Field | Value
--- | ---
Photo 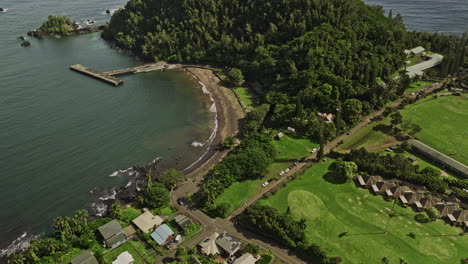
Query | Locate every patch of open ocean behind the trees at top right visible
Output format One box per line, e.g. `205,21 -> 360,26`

364,0 -> 468,35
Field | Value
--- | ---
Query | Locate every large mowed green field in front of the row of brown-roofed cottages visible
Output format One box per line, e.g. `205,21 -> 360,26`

259,161 -> 468,264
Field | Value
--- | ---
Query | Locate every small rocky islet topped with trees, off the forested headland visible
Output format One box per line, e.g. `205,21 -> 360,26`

28,15 -> 104,38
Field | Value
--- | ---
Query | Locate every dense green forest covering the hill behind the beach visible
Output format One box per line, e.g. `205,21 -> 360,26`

103,0 -> 407,134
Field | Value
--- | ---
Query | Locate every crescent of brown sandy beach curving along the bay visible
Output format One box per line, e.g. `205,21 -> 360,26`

181,67 -> 245,178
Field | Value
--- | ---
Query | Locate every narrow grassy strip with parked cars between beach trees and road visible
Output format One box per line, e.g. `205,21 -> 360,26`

215,135 -> 318,214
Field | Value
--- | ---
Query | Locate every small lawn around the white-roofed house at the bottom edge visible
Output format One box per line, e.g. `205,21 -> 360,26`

104,241 -> 156,264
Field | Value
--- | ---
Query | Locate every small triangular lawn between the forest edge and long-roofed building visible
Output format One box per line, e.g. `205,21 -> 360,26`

338,122 -> 391,150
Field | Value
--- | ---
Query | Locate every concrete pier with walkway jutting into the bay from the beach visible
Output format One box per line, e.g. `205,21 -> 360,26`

70,61 -> 182,86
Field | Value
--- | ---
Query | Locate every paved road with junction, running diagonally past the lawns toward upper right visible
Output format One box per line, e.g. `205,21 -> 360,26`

160,77 -> 450,264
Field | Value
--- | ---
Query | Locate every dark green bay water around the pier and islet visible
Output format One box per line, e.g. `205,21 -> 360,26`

0,0 -> 213,254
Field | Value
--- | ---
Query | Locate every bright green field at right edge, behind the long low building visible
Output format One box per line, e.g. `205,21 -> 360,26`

401,96 -> 468,165
